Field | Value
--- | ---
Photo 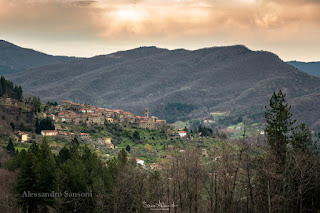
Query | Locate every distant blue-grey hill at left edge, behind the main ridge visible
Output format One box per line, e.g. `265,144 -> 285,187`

0,40 -> 77,75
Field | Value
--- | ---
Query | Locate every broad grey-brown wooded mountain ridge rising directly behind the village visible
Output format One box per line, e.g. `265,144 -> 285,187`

8,45 -> 320,130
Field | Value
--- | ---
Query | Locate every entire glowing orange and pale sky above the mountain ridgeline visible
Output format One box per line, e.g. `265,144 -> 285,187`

0,0 -> 320,61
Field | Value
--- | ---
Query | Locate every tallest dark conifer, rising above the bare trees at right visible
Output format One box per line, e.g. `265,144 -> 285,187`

265,90 -> 295,161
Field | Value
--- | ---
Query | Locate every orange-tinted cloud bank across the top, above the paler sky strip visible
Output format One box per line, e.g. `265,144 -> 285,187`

0,0 -> 320,38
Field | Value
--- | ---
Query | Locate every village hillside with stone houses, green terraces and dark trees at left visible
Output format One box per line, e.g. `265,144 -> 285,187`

0,75 -> 195,168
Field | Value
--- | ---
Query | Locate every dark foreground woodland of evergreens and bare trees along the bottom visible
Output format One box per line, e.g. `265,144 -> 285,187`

0,91 -> 320,213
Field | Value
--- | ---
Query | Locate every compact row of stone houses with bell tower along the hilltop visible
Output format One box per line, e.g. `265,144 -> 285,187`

53,100 -> 166,129
